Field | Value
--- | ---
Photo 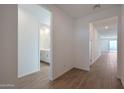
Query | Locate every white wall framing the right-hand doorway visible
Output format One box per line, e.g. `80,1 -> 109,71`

75,6 -> 121,70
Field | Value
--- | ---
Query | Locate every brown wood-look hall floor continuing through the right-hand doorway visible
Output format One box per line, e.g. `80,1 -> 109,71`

49,53 -> 122,89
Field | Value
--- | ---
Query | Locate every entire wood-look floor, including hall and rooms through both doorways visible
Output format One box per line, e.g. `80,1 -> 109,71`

18,53 -> 123,89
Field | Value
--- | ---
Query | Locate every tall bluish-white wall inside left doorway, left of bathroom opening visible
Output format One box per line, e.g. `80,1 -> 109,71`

18,5 -> 39,77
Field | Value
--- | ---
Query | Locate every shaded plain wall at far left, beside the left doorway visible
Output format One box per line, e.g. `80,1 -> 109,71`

0,5 -> 18,88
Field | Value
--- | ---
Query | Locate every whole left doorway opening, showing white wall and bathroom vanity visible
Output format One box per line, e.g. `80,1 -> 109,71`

18,4 -> 53,81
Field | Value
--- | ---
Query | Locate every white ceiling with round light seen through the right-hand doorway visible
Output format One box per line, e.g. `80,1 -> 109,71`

93,17 -> 118,37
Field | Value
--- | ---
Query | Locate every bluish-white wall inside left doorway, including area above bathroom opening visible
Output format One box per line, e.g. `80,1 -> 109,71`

18,5 -> 50,77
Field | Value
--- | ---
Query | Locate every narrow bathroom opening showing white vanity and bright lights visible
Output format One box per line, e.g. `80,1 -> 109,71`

39,20 -> 52,80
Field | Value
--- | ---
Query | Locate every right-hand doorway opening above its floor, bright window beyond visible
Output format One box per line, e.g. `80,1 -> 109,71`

89,16 -> 118,69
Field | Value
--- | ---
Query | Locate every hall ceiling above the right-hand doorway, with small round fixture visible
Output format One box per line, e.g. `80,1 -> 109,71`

56,4 -> 119,18
